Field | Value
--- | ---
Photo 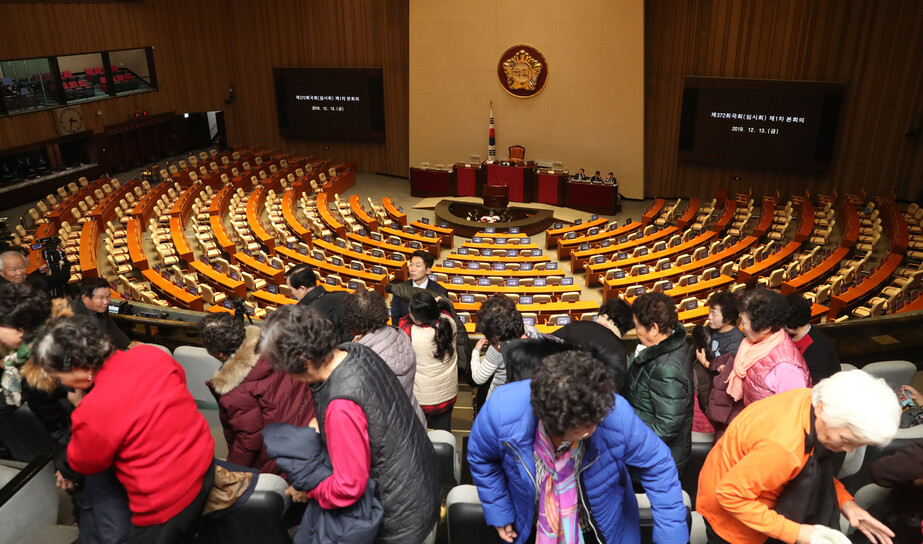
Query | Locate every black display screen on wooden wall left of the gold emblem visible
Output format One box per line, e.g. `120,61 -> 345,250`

273,67 -> 385,141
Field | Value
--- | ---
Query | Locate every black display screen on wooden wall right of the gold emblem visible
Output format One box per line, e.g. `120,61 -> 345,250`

678,77 -> 844,172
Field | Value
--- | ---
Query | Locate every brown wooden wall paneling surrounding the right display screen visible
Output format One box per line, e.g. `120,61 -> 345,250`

645,0 -> 923,200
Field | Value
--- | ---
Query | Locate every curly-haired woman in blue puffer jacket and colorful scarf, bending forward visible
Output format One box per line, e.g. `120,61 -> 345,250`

468,351 -> 689,543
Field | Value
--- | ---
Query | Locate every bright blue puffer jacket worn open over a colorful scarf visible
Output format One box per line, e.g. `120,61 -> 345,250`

468,381 -> 689,544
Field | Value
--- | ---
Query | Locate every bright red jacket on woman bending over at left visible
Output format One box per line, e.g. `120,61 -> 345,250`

67,346 -> 215,526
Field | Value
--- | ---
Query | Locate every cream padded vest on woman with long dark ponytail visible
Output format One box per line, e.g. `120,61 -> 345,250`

410,316 -> 458,406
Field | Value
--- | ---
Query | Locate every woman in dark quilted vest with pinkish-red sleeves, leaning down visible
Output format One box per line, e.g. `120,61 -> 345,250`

259,305 -> 440,544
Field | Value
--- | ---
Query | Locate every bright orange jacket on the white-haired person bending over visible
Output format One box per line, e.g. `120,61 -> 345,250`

696,389 -> 853,544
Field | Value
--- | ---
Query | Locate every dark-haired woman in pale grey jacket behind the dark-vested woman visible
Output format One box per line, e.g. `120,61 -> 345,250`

342,289 -> 426,425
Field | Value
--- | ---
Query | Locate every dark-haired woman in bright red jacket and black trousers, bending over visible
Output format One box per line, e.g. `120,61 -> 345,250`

34,316 -> 215,542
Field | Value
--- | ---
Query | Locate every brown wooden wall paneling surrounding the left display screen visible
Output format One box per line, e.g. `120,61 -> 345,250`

225,0 -> 409,176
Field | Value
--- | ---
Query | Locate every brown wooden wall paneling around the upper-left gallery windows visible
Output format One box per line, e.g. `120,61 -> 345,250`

0,0 -> 232,154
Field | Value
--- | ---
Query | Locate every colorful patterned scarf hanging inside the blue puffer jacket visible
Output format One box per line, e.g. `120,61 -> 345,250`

535,421 -> 583,544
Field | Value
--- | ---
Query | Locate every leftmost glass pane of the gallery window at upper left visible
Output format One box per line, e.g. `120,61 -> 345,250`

0,58 -> 60,113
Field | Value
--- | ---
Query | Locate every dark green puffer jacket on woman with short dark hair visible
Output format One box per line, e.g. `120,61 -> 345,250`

625,324 -> 694,476
